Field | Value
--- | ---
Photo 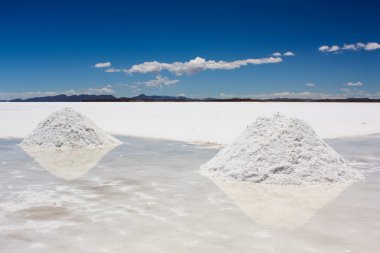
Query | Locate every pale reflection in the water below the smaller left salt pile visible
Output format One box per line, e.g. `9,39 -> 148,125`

23,146 -> 116,181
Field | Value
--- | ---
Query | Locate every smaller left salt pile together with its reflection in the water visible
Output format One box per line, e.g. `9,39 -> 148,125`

21,108 -> 121,180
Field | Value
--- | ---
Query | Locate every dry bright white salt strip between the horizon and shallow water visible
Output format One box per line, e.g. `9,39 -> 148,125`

0,102 -> 380,144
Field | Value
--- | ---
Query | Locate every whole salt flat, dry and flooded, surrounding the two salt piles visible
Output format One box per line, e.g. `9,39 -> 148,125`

0,103 -> 380,253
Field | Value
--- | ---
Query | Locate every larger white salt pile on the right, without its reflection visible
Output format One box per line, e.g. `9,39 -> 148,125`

200,114 -> 363,185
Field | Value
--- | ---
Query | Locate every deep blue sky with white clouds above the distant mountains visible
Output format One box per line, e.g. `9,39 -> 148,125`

0,0 -> 380,99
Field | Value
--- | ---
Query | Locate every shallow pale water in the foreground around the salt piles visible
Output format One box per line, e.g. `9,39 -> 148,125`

0,135 -> 380,253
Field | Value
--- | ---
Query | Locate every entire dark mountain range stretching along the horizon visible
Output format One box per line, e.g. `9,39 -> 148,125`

0,94 -> 380,102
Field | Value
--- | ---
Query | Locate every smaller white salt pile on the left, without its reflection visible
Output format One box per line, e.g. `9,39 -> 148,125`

21,108 -> 121,149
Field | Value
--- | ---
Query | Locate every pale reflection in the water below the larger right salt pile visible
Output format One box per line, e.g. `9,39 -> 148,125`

212,178 -> 351,230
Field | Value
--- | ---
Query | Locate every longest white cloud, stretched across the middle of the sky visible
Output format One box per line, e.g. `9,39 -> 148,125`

124,57 -> 282,76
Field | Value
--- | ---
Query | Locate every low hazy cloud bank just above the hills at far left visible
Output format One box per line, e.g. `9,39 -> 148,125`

0,85 -> 115,100
